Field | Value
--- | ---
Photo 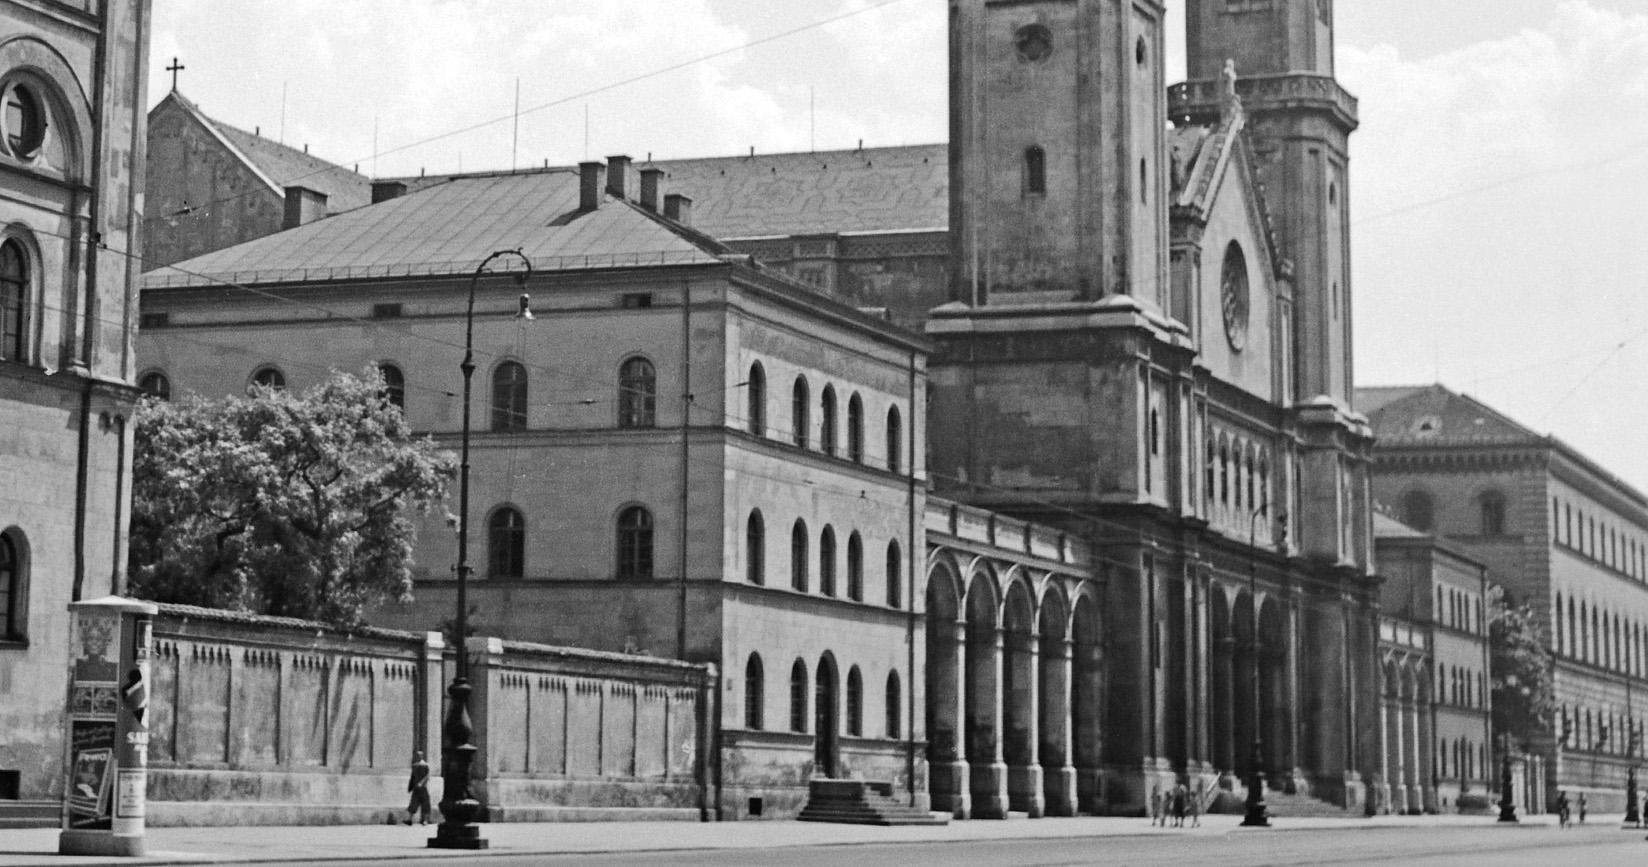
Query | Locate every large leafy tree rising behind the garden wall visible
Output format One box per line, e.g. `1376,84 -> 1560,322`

130,369 -> 455,626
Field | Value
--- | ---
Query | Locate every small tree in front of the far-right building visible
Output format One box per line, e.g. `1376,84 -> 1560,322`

1488,585 -> 1556,743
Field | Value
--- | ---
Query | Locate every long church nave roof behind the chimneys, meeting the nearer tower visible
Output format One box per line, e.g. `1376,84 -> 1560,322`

394,143 -> 949,241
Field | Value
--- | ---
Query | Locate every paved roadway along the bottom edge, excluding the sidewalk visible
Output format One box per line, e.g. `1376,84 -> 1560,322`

276,826 -> 1648,867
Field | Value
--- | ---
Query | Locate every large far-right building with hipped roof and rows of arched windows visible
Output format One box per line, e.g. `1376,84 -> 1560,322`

1360,386 -> 1648,813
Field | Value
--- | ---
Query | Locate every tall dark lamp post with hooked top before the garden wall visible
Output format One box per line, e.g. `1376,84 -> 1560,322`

428,249 -> 532,849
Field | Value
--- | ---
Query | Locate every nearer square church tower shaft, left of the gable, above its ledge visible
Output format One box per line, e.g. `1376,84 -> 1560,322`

949,0 -> 1168,308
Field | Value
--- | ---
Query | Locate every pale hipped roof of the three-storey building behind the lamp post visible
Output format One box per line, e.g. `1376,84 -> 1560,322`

143,170 -> 727,288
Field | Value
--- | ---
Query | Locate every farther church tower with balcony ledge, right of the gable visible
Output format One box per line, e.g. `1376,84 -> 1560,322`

1170,0 -> 1356,407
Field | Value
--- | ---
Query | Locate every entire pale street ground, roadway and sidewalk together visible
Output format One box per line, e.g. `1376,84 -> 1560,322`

0,816 -> 1648,867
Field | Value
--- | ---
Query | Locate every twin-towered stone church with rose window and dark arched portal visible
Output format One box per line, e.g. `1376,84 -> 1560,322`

926,0 -> 1378,809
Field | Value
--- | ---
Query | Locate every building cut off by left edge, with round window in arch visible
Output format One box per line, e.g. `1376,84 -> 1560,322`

0,0 -> 150,821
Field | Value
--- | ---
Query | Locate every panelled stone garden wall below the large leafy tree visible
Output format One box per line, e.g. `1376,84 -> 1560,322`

148,605 -> 715,826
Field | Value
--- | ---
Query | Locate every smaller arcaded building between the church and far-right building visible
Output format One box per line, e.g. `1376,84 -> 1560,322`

1373,514 -> 1500,813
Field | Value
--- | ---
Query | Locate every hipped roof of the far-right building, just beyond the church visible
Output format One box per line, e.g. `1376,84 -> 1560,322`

1356,384 -> 1546,445
